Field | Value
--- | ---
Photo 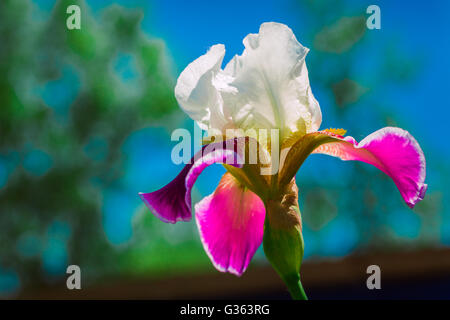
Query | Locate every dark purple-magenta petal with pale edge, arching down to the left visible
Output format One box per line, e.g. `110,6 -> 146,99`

139,138 -> 243,223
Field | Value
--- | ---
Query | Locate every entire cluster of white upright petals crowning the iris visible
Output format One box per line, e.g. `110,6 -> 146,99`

175,22 -> 322,138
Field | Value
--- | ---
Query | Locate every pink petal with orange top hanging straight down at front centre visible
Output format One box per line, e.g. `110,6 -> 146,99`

195,173 -> 265,276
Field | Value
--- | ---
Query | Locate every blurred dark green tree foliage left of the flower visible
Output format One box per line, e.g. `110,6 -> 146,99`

0,0 -> 177,287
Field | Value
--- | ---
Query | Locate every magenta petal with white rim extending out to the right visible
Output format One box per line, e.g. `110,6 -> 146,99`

314,127 -> 427,208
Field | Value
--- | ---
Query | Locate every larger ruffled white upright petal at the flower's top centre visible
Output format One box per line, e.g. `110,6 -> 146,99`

219,22 -> 322,137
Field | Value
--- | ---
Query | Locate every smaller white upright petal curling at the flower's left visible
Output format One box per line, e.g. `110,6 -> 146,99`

175,44 -> 225,130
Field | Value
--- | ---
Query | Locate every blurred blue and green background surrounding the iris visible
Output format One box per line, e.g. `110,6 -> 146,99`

0,0 -> 450,299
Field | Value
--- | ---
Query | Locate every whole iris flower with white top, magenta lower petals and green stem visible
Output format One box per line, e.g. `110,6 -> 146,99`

140,22 -> 427,299
